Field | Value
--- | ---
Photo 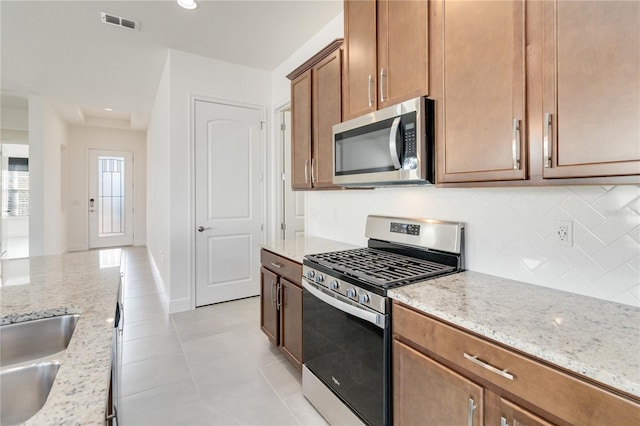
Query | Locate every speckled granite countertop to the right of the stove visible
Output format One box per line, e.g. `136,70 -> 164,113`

389,271 -> 640,397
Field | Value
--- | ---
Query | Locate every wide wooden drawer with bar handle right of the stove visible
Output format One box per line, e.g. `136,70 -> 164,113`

393,302 -> 640,425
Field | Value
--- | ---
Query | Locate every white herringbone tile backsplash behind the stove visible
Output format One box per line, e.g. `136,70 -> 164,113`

307,185 -> 640,306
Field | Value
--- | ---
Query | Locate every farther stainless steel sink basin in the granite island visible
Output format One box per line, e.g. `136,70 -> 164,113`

0,315 -> 80,366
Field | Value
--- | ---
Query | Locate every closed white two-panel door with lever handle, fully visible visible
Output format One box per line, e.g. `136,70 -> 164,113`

194,100 -> 262,306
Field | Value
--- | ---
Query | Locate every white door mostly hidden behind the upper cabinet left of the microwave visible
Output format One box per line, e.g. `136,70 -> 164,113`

280,109 -> 306,238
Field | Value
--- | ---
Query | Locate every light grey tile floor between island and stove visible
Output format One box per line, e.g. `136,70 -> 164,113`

119,247 -> 326,426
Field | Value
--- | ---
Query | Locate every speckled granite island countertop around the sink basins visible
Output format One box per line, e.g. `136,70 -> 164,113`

0,250 -> 120,425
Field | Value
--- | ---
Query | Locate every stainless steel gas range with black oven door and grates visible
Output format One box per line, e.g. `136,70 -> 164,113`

302,216 -> 464,425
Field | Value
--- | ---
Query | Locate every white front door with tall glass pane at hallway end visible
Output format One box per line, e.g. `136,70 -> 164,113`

88,149 -> 133,248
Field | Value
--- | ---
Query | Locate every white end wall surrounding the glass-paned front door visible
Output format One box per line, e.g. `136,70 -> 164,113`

63,126 -> 147,251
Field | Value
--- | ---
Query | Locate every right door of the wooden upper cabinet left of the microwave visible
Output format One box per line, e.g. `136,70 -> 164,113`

311,49 -> 342,188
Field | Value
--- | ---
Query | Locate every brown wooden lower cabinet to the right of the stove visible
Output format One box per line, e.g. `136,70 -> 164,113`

393,302 -> 640,426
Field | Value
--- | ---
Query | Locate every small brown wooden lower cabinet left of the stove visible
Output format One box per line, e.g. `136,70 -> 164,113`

260,249 -> 302,371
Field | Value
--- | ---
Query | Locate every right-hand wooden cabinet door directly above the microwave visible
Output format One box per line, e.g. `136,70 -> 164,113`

377,0 -> 429,109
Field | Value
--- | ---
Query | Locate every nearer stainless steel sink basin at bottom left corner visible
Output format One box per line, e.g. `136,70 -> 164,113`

0,361 -> 60,425
